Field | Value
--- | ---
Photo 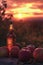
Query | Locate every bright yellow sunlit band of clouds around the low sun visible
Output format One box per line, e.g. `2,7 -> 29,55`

6,3 -> 43,19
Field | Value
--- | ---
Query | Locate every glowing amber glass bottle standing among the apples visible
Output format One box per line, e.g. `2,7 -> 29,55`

7,22 -> 16,52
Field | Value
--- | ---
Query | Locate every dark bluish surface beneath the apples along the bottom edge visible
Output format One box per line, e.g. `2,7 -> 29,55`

0,58 -> 43,65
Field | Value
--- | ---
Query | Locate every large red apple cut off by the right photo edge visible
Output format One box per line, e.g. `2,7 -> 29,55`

33,48 -> 43,62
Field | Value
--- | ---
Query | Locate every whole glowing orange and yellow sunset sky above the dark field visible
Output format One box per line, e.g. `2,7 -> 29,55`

0,0 -> 43,19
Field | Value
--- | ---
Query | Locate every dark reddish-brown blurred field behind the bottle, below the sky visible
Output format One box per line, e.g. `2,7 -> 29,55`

0,19 -> 43,46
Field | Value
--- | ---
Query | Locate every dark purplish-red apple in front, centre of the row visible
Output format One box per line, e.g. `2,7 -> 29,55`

19,48 -> 31,62
